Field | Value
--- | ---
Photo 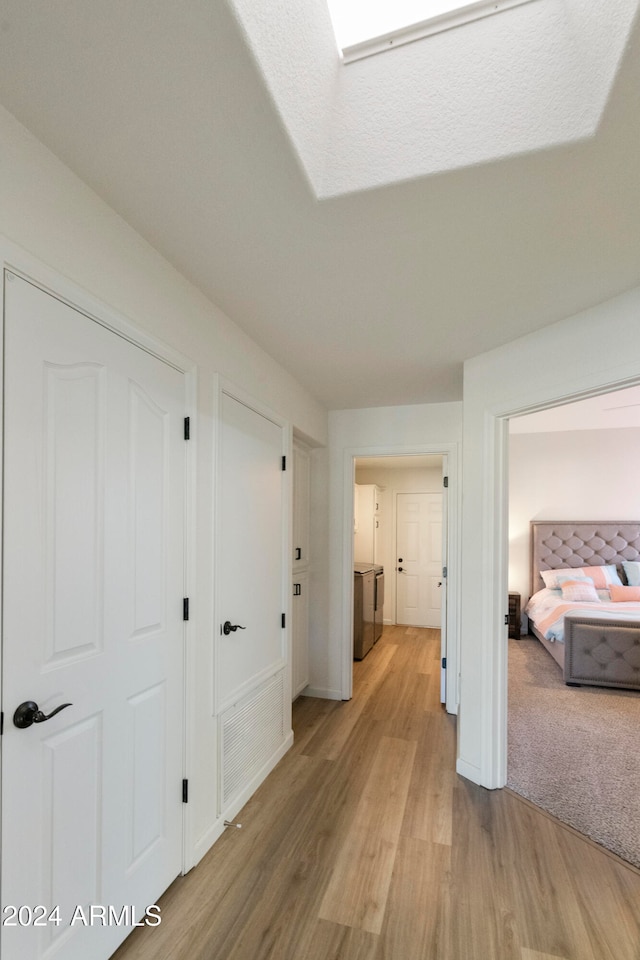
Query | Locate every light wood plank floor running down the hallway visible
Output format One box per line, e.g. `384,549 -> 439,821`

115,627 -> 640,960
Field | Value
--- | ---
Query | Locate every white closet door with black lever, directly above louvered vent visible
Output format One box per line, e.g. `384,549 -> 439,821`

217,392 -> 287,710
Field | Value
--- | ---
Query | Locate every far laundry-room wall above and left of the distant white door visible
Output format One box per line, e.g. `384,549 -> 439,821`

356,461 -> 442,624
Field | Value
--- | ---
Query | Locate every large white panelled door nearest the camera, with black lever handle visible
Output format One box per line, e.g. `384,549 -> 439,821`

1,275 -> 185,960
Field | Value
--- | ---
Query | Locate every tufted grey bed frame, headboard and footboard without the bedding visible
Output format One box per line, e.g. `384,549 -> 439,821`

530,520 -> 640,690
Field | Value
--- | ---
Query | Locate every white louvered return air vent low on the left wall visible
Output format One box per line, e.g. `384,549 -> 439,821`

222,672 -> 284,809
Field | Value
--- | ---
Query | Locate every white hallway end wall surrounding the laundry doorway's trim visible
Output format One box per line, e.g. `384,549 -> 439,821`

318,403 -> 462,699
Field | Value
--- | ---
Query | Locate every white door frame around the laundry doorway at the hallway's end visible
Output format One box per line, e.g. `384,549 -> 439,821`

341,443 -> 461,713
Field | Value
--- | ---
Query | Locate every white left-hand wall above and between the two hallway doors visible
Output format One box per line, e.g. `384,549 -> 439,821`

0,108 -> 327,868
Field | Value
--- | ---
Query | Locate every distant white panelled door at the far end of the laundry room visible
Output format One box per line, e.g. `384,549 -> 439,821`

396,493 -> 442,627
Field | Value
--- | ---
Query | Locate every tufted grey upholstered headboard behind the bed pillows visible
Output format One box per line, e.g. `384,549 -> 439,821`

531,520 -> 640,593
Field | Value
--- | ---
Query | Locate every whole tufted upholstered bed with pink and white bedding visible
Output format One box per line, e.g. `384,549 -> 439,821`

525,520 -> 640,690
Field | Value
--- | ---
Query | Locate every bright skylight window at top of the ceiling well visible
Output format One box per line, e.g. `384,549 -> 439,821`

327,0 -> 532,63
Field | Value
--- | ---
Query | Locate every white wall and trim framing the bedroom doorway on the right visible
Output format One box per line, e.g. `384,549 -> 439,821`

458,288 -> 640,787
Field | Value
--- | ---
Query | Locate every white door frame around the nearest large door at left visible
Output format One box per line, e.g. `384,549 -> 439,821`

0,236 -> 197,873
